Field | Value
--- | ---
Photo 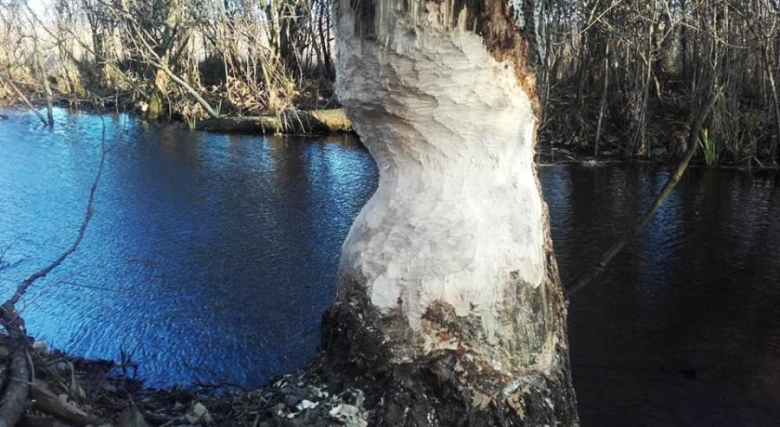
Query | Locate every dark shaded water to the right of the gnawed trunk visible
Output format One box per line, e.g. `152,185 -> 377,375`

542,166 -> 780,426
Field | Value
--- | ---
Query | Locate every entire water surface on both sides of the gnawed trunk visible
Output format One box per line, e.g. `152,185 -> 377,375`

0,112 -> 780,426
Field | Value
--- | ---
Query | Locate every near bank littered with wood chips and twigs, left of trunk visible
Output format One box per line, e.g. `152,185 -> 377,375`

0,336 -> 368,427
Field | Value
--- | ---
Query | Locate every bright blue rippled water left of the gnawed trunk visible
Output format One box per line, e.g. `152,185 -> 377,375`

0,111 -> 376,386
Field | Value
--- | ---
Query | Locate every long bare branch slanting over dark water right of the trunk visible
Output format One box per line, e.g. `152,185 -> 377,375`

566,89 -> 721,298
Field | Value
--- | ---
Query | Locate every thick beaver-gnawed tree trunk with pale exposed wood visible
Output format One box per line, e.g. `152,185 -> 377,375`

323,0 -> 577,426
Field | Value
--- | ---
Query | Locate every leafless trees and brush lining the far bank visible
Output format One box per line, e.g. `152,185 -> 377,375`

0,0 -> 780,165
